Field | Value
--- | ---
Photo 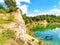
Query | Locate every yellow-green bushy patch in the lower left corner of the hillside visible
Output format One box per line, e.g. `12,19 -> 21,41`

0,29 -> 15,45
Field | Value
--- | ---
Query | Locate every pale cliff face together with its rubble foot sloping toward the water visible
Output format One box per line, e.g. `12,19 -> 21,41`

10,9 -> 38,45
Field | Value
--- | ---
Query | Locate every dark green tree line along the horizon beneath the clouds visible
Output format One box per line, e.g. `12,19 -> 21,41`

23,14 -> 60,24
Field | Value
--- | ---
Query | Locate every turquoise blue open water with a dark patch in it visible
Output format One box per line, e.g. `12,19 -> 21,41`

34,28 -> 60,45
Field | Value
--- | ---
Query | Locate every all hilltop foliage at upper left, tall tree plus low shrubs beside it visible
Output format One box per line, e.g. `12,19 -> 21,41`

0,0 -> 17,13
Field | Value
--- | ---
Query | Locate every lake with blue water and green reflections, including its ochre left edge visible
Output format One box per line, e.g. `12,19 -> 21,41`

27,23 -> 60,45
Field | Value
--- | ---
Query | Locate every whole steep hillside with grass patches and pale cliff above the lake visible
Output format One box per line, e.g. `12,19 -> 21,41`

0,8 -> 42,45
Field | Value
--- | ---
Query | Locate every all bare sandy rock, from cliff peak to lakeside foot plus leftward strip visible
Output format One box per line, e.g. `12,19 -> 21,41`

0,8 -> 39,45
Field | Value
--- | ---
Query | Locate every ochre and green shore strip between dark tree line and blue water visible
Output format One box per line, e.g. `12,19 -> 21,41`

26,22 -> 60,35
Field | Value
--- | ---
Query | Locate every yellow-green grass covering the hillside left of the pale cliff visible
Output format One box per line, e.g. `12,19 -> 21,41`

0,9 -> 24,45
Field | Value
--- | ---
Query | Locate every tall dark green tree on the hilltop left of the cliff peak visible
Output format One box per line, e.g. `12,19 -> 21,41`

4,0 -> 17,12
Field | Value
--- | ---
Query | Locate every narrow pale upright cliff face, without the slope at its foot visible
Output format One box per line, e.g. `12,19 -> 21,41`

12,9 -> 26,40
